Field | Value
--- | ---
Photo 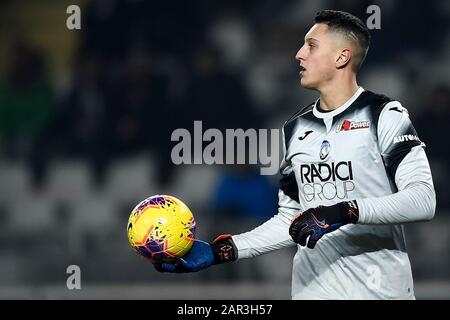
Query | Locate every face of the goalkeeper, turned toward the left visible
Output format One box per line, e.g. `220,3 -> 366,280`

295,23 -> 339,89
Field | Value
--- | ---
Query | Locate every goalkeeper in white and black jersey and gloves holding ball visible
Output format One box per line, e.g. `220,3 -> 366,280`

156,10 -> 436,299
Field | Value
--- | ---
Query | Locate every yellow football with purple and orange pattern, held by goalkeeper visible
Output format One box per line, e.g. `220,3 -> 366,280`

127,195 -> 195,263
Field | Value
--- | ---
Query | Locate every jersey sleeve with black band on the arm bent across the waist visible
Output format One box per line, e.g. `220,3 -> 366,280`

357,101 -> 436,224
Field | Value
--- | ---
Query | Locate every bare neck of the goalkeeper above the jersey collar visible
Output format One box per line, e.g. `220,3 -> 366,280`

319,79 -> 358,111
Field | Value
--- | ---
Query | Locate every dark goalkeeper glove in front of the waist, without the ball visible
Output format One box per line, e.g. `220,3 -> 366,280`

289,201 -> 359,249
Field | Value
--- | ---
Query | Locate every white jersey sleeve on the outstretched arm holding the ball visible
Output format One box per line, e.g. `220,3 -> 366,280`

233,126 -> 300,259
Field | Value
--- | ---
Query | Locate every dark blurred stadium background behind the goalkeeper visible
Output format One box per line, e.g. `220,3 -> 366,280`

0,0 -> 450,299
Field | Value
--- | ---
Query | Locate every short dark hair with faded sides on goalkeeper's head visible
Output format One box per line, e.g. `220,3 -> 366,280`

314,10 -> 370,71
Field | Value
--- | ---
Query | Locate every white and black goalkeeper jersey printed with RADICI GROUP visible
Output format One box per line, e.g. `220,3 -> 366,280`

233,88 -> 436,299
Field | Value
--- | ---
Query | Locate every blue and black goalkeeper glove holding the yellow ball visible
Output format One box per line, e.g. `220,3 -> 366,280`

155,234 -> 237,273
